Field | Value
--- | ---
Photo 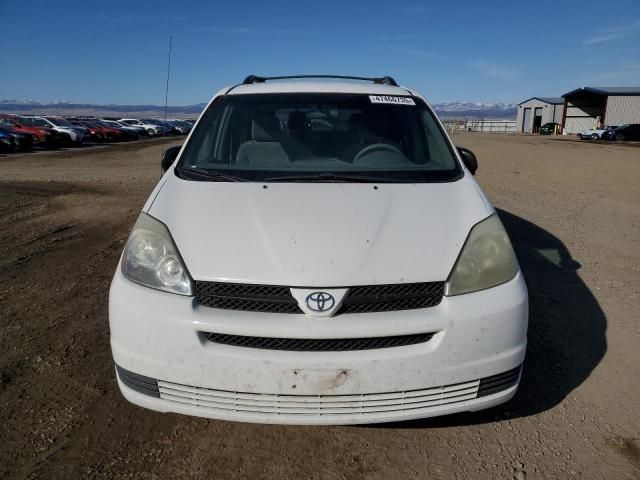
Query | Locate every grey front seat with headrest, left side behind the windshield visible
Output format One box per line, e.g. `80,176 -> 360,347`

236,115 -> 289,168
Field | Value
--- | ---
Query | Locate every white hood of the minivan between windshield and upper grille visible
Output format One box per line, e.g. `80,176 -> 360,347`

148,177 -> 492,287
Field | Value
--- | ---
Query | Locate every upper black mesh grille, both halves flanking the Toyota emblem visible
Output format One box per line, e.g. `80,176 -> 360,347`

196,281 -> 444,315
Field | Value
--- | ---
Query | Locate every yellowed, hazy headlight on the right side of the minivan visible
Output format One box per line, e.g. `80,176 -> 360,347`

445,214 -> 518,296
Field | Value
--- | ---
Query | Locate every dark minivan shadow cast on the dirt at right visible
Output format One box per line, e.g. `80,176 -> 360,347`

379,209 -> 607,428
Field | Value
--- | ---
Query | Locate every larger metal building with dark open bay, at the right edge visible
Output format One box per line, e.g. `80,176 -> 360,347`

560,87 -> 640,133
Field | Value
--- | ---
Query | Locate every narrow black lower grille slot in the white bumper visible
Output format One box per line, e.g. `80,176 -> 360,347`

206,333 -> 433,352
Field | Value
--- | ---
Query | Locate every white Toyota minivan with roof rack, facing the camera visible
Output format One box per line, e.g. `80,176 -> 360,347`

109,75 -> 528,424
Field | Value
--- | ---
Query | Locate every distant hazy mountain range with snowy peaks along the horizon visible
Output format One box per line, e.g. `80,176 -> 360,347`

0,100 -> 518,120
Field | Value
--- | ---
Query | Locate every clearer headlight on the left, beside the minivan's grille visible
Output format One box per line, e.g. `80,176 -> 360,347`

122,213 -> 193,295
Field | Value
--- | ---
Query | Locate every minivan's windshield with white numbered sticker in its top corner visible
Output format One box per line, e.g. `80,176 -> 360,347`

177,93 -> 462,182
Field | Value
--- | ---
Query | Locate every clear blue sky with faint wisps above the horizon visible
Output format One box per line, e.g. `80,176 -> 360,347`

0,0 -> 640,105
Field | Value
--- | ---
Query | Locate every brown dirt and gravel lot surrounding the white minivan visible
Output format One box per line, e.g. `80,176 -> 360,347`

0,134 -> 640,479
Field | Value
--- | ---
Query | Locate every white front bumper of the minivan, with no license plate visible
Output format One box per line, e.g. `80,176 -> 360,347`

109,270 -> 528,424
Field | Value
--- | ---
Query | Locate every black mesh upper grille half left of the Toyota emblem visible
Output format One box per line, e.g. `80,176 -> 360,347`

196,282 -> 302,313
